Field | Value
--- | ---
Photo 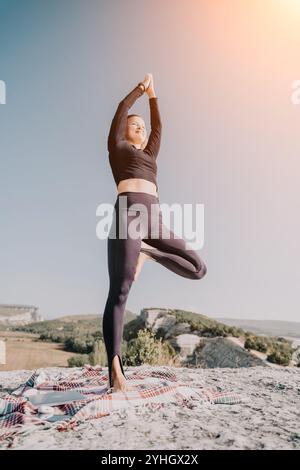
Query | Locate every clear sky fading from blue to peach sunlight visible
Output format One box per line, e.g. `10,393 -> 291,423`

0,0 -> 300,320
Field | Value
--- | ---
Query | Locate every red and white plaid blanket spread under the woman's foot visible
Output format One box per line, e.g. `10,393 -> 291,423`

0,365 -> 243,440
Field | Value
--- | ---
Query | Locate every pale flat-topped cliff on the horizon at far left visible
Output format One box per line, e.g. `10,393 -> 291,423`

0,304 -> 43,326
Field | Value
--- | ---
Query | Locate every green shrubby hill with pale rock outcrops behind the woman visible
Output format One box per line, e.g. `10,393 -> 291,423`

2,308 -> 300,368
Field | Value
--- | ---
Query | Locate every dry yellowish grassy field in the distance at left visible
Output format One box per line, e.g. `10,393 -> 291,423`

0,331 -> 81,371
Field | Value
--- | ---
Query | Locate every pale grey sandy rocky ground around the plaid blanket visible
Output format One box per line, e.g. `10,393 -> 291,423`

0,367 -> 300,450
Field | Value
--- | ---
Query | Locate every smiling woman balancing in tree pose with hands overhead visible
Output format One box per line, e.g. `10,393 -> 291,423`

103,73 -> 207,392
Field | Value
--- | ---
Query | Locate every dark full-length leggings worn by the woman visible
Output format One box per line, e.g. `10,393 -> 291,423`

103,191 -> 207,387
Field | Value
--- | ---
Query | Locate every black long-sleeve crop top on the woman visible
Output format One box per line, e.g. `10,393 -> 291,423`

107,85 -> 162,188
